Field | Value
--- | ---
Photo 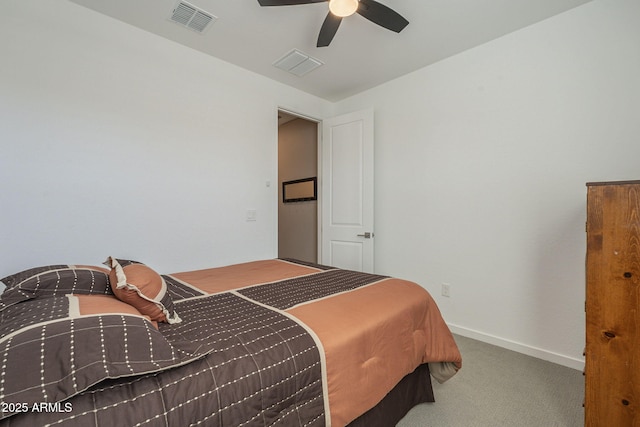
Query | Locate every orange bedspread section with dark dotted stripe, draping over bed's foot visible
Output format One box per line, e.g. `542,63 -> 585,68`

173,260 -> 462,426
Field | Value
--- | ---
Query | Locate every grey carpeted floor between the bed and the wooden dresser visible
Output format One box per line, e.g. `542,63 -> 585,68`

397,335 -> 584,427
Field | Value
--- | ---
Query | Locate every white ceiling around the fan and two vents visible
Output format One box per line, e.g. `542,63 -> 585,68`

71,0 -> 591,101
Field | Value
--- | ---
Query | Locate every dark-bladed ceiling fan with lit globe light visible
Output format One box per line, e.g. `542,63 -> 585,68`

258,0 -> 409,47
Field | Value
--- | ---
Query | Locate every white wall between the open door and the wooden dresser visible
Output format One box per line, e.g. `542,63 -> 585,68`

337,0 -> 640,368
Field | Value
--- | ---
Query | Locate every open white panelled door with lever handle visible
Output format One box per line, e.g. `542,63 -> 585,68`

320,109 -> 374,273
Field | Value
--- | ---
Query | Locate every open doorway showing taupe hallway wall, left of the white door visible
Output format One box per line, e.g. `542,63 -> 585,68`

278,110 -> 318,262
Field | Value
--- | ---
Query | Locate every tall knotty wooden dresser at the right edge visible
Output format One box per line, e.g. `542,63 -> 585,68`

585,181 -> 640,427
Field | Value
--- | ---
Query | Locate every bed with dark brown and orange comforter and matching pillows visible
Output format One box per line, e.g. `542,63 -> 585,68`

0,257 -> 462,427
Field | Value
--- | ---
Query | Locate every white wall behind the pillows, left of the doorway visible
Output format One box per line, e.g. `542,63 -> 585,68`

0,0 -> 331,277
